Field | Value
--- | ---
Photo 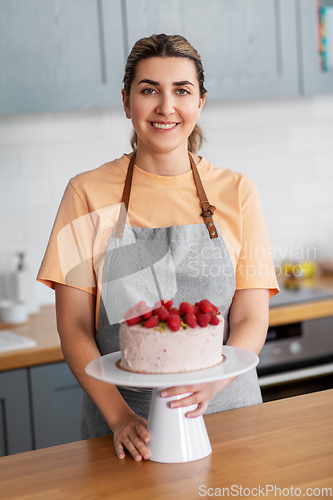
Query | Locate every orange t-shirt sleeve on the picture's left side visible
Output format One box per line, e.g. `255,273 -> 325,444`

37,181 -> 96,295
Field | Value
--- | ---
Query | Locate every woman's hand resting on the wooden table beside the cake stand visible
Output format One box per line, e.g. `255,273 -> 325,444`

113,413 -> 150,461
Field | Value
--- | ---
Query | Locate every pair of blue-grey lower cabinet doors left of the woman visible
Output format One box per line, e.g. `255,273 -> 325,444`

0,362 -> 82,456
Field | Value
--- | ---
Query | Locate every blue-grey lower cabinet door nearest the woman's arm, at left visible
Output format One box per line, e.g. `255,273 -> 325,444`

29,362 -> 82,449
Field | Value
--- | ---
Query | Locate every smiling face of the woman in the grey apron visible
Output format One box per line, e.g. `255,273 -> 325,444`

122,57 -> 206,154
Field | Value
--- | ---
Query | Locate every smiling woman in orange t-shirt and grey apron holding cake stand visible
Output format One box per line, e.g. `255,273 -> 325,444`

38,34 -> 278,460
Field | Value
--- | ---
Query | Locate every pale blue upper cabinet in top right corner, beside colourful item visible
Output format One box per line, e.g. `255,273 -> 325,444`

297,0 -> 333,95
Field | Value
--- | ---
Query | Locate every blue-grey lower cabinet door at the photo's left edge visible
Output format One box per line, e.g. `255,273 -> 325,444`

0,368 -> 33,457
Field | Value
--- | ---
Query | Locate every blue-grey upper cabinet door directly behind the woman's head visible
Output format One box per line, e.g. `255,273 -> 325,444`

126,0 -> 298,102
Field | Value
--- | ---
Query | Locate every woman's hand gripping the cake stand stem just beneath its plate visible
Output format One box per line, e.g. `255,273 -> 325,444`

162,379 -> 234,418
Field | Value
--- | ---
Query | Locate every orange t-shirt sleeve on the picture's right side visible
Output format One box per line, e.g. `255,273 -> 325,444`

236,177 -> 279,296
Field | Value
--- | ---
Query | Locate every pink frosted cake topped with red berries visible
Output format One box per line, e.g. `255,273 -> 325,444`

119,300 -> 224,373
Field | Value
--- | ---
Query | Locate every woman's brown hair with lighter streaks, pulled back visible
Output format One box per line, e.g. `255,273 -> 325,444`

123,33 -> 207,153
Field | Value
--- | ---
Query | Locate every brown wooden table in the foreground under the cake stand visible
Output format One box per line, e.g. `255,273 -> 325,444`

0,390 -> 333,500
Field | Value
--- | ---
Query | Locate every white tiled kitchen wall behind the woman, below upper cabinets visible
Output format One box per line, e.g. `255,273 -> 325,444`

0,95 -> 333,305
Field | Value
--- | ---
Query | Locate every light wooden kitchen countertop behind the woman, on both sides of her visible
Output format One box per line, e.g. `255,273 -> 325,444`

0,275 -> 333,372
